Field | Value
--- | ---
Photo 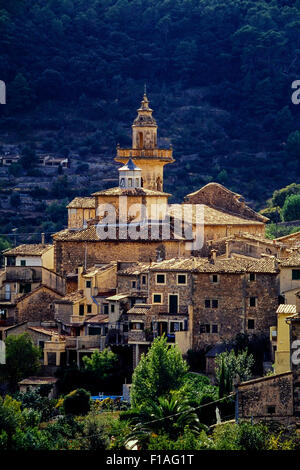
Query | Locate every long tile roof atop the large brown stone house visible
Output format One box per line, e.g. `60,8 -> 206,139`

149,257 -> 279,274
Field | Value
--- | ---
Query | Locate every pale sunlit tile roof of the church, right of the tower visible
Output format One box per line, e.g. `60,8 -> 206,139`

169,204 -> 264,225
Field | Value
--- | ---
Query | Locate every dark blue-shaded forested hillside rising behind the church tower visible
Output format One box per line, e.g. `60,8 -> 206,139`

0,0 -> 300,239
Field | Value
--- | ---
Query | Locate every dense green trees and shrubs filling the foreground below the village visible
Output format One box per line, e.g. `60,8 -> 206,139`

0,338 -> 297,451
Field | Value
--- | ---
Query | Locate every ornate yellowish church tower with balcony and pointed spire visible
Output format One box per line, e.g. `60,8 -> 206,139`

115,90 -> 174,191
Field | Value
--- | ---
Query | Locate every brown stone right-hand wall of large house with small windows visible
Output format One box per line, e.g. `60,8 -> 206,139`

192,273 -> 279,349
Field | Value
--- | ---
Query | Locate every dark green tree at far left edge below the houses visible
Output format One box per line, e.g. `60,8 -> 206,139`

4,333 -> 40,387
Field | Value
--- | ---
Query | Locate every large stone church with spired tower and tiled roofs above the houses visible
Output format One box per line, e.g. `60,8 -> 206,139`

53,94 -> 268,275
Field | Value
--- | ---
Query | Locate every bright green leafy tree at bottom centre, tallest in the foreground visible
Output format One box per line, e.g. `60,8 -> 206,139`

131,336 -> 188,406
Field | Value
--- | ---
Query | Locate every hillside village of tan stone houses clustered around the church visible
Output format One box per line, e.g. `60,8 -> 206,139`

0,93 -> 300,430
